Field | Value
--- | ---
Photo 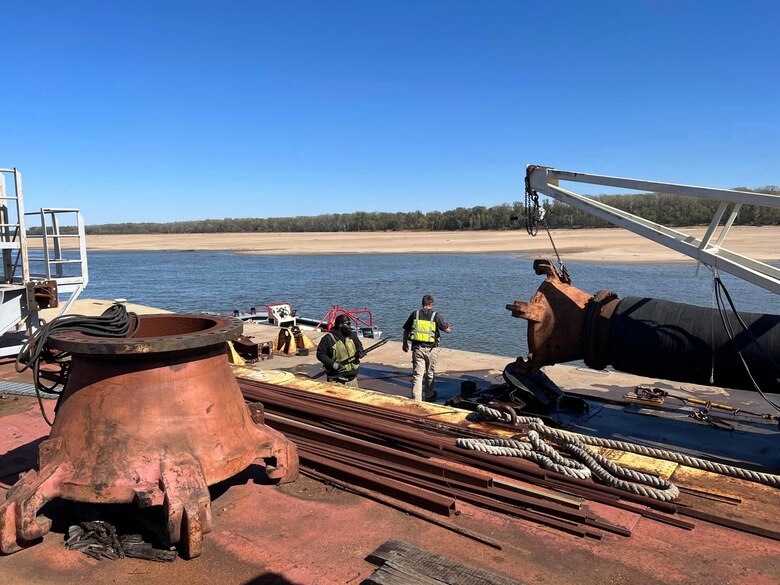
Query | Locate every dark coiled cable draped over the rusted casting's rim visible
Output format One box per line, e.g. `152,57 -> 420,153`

16,303 -> 140,426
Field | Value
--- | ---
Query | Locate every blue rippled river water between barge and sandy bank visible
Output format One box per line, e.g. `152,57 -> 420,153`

82,252 -> 780,357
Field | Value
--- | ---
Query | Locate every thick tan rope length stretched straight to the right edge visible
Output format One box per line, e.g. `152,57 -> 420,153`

464,404 -> 780,487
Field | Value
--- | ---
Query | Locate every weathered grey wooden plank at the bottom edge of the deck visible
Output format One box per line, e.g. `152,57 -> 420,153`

366,540 -> 522,585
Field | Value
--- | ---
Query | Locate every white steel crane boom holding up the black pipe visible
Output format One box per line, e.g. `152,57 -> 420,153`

526,165 -> 780,294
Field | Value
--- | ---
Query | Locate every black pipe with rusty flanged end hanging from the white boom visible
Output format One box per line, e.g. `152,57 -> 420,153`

506,260 -> 780,391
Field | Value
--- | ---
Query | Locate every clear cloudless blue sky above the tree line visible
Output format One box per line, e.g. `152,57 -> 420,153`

0,0 -> 780,223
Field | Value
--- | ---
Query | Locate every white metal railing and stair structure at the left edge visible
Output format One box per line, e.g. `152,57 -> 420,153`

0,169 -> 89,356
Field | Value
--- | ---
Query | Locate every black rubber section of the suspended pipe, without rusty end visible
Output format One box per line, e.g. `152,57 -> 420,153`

606,297 -> 780,393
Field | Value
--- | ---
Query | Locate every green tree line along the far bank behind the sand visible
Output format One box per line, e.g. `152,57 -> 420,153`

82,185 -> 780,234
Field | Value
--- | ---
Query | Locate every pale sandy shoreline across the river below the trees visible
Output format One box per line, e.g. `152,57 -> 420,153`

74,226 -> 780,263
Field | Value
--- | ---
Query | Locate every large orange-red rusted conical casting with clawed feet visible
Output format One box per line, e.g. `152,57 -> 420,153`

0,315 -> 298,558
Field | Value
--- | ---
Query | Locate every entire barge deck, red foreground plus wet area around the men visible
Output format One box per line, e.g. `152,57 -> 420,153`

0,301 -> 780,585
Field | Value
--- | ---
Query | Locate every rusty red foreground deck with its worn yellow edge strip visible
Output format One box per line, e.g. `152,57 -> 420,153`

0,346 -> 780,585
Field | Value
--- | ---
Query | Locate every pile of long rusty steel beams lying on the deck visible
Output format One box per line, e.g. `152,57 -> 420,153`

238,378 -> 780,544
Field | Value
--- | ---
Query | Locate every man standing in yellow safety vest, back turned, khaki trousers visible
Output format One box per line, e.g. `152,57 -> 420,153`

403,295 -> 452,402
